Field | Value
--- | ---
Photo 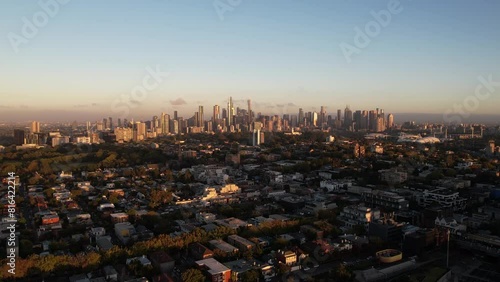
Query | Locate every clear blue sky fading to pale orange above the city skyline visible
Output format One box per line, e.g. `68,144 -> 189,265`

0,0 -> 500,121
